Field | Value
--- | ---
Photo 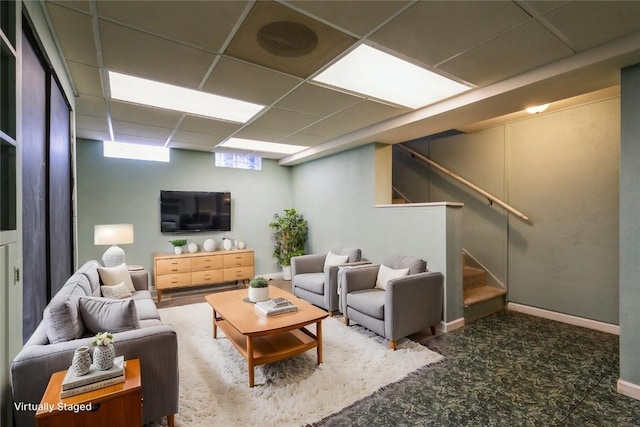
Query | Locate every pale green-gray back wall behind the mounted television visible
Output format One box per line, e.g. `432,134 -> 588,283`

77,140 -> 292,274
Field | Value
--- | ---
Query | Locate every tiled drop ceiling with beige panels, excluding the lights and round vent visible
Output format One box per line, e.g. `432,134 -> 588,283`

43,0 -> 640,165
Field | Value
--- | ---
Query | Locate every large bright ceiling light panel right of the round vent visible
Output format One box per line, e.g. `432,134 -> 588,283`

313,45 -> 470,108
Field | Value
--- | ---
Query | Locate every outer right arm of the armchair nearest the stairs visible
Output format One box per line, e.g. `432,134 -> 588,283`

384,272 -> 444,340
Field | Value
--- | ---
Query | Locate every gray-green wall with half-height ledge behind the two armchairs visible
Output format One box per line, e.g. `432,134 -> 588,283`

292,144 -> 463,322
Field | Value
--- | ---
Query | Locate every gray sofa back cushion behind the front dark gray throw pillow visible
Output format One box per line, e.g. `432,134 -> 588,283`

42,275 -> 86,343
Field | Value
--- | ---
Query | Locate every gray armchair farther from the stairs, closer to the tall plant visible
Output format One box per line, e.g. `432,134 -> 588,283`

291,248 -> 368,314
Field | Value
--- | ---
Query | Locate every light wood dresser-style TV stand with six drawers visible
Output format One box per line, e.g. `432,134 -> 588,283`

153,249 -> 255,301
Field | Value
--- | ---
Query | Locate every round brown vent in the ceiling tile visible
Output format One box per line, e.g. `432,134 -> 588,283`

258,21 -> 318,57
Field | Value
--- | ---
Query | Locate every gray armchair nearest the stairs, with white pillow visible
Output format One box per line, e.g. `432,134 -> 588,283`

339,256 -> 444,350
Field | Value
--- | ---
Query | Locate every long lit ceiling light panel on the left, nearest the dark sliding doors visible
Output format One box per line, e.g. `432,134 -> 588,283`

109,71 -> 264,123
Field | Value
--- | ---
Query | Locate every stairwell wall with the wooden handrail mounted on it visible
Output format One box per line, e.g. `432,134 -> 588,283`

394,98 -> 620,324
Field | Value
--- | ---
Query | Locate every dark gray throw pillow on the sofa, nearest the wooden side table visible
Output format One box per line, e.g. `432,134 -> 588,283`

78,297 -> 140,334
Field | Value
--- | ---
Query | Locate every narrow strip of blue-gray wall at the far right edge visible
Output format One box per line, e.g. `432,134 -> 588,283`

620,65 -> 640,388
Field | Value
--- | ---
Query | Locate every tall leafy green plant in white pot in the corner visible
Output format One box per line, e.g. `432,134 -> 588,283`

269,209 -> 309,280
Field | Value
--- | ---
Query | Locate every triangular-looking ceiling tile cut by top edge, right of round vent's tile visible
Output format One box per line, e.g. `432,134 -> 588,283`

291,0 -> 409,36
